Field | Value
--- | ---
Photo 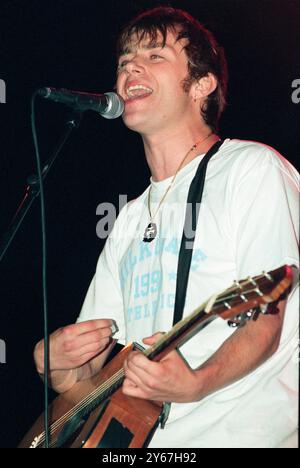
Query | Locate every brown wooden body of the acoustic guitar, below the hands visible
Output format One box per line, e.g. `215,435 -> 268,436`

19,344 -> 162,448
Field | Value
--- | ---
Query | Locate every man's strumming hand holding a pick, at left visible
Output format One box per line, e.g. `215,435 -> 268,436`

34,319 -> 114,374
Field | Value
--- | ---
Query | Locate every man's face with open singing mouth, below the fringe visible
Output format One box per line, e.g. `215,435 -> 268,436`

117,32 -> 191,135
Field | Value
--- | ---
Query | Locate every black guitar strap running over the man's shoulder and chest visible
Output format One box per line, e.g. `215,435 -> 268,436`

173,140 -> 223,325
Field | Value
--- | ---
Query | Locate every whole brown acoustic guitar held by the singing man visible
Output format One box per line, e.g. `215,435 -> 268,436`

19,265 -> 296,448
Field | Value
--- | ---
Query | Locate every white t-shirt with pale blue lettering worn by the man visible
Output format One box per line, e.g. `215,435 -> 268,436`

78,139 -> 299,448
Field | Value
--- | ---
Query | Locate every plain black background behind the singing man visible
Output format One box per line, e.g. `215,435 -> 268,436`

0,0 -> 300,447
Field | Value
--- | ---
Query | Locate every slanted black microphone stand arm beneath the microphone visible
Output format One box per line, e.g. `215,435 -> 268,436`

0,111 -> 81,261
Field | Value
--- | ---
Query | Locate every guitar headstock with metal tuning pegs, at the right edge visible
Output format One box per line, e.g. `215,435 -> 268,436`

212,265 -> 297,320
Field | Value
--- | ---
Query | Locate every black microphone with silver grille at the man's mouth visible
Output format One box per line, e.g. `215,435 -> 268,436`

38,88 -> 124,119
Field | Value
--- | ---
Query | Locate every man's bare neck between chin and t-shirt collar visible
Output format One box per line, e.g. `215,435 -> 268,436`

142,125 -> 219,182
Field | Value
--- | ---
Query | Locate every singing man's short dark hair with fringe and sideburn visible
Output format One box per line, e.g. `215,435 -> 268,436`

117,6 -> 228,131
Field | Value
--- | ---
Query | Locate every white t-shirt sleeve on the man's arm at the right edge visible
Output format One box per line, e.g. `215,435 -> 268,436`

230,145 -> 299,279
